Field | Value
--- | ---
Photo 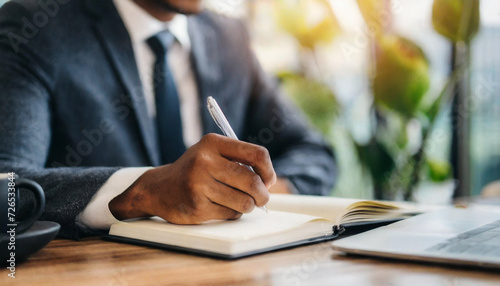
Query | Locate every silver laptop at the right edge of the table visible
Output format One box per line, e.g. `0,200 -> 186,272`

333,207 -> 500,268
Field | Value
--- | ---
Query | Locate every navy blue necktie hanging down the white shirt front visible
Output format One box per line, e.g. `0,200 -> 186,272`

147,31 -> 186,164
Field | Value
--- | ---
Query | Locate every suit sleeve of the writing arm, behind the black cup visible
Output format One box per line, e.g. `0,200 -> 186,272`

0,3 -> 118,239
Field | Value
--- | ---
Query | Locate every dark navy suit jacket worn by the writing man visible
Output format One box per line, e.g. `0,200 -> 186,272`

0,0 -> 335,238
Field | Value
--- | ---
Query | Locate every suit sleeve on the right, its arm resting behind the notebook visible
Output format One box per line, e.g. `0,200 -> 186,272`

237,24 -> 337,195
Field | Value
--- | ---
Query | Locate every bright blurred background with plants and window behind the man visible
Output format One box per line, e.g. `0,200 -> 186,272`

0,0 -> 500,203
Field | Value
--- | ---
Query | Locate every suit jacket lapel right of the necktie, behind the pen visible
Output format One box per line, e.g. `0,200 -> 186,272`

188,15 -> 224,134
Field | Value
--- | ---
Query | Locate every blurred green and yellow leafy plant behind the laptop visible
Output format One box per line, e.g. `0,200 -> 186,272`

355,0 -> 479,199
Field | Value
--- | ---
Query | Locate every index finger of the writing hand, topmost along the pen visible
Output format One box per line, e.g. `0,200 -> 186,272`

206,135 -> 276,189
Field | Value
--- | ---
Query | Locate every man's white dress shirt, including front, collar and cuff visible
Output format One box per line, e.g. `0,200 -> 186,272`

76,0 -> 202,229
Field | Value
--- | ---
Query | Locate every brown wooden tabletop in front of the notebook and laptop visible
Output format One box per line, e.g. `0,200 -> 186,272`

0,238 -> 500,286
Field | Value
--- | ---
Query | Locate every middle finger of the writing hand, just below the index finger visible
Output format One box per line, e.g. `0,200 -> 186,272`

209,157 -> 269,206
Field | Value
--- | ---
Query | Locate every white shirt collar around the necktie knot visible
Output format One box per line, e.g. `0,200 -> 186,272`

113,0 -> 191,49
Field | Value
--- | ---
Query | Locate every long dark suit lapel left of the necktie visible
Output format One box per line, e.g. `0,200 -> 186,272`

83,0 -> 160,166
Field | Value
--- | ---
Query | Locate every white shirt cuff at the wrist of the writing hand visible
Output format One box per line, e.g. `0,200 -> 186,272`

76,167 -> 152,229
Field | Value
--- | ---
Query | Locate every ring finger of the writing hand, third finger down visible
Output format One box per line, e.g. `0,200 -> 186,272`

205,182 -> 255,213
